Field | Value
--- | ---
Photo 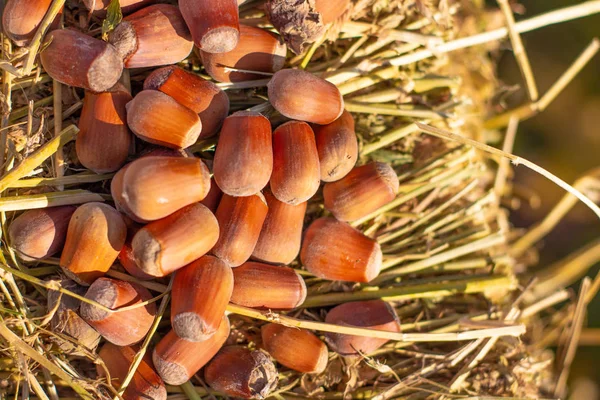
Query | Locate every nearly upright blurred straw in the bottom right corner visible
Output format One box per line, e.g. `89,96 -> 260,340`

554,277 -> 591,398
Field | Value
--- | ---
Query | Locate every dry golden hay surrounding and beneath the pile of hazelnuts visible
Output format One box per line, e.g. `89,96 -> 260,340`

0,0 -> 600,400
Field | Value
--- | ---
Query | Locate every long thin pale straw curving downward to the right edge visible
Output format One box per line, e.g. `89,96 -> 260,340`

416,122 -> 600,222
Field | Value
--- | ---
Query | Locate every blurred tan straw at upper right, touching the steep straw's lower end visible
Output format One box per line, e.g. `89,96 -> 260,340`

485,38 -> 600,129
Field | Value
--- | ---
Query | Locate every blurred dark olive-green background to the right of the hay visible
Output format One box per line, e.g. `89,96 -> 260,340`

488,0 -> 600,394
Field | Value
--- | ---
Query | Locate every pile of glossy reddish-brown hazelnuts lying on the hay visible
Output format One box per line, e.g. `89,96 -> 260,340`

3,0 -> 399,399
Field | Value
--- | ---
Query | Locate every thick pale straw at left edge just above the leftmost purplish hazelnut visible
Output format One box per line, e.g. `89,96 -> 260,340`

0,189 -> 112,212
